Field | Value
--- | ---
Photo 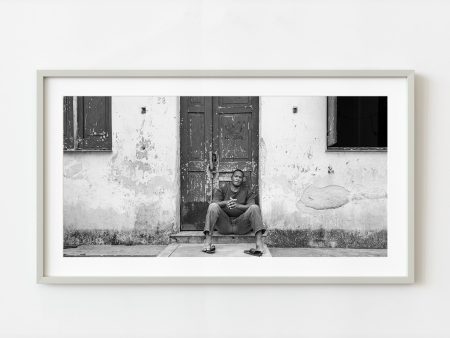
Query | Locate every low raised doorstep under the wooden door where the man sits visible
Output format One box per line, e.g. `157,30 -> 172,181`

170,231 -> 266,244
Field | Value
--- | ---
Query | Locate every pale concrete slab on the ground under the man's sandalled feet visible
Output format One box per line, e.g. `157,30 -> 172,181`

158,243 -> 272,258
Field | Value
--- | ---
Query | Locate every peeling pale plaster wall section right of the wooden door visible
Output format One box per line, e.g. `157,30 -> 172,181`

260,97 -> 387,231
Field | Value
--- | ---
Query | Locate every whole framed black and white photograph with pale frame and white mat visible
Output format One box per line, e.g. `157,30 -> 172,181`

37,70 -> 414,284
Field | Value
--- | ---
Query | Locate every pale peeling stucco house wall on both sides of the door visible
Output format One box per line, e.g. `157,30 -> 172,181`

64,97 -> 387,232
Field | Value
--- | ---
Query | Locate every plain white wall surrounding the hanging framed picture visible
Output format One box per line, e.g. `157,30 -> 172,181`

0,0 -> 450,338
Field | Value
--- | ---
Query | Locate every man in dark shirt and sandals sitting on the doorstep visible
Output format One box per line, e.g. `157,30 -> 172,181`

203,169 -> 266,256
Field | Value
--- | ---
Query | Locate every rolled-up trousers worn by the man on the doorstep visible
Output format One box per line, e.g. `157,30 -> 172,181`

203,203 -> 266,235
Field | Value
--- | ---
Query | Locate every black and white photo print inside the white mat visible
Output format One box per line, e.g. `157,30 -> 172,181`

60,95 -> 390,259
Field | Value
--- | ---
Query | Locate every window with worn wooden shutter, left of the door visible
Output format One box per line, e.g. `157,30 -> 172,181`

63,96 -> 112,151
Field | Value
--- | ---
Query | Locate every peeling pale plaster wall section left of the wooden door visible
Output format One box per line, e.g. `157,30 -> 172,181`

64,97 -> 179,231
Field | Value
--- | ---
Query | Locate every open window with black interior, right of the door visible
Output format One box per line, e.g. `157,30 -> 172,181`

327,96 -> 387,151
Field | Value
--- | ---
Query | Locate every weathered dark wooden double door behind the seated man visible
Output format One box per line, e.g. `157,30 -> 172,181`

180,96 -> 259,230
